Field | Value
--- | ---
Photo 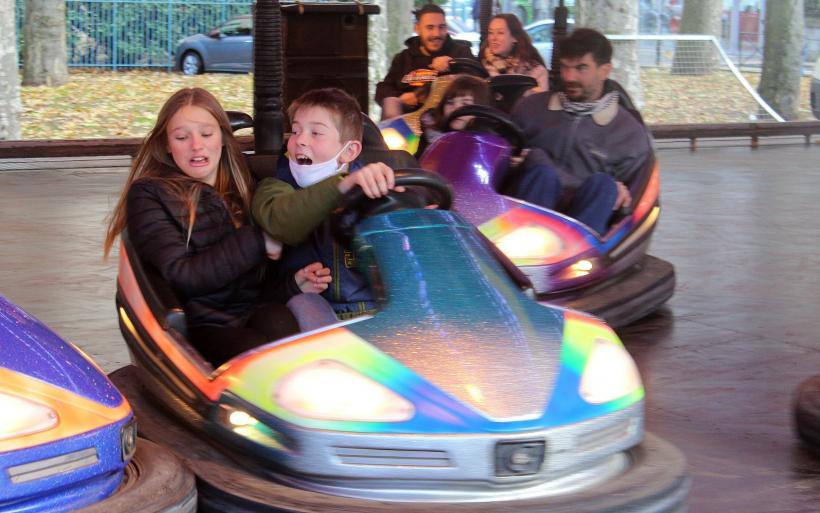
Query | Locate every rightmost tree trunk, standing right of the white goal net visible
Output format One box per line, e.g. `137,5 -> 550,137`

757,0 -> 803,119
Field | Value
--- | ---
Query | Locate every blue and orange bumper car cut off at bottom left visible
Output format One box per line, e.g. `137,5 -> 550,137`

0,295 -> 196,513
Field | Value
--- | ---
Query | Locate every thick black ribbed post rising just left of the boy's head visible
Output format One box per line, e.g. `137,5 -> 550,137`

251,0 -> 284,156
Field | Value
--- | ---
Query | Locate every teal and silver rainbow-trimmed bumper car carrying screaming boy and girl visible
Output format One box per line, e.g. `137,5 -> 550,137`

111,170 -> 689,513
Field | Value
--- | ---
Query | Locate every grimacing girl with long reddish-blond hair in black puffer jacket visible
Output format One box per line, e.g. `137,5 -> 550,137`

104,88 -> 335,365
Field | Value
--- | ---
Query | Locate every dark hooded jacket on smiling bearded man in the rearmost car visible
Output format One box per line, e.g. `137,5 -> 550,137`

376,36 -> 475,105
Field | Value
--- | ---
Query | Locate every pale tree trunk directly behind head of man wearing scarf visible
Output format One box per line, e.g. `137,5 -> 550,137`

575,0 -> 644,109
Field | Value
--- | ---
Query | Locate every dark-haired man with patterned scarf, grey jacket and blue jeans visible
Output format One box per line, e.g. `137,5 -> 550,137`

506,28 -> 652,234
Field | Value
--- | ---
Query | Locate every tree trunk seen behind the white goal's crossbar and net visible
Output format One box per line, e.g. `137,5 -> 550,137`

672,0 -> 723,75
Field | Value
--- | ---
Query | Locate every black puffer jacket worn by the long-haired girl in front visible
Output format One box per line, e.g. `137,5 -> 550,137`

126,179 -> 296,326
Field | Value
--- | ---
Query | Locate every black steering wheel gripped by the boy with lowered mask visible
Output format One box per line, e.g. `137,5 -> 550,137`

330,168 -> 453,246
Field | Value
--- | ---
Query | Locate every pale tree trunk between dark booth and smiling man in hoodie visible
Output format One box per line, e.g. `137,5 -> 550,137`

367,0 -> 414,119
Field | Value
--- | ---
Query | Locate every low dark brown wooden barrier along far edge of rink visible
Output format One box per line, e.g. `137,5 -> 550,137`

0,121 -> 820,158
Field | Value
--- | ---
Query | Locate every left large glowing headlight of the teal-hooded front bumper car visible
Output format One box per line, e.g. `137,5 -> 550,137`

274,360 -> 414,422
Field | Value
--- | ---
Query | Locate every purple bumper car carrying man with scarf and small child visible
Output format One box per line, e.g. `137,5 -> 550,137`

419,105 -> 675,328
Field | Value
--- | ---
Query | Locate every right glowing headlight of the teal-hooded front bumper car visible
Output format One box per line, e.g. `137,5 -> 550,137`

580,338 -> 641,404
